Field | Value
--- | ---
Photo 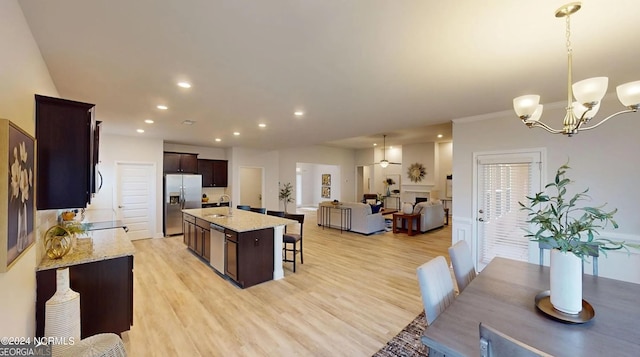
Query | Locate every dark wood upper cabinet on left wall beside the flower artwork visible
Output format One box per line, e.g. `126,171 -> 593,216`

35,95 -> 99,210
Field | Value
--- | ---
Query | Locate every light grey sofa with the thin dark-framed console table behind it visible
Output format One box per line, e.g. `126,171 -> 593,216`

317,201 -> 385,235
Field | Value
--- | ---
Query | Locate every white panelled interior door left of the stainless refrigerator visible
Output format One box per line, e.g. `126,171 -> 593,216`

114,163 -> 156,240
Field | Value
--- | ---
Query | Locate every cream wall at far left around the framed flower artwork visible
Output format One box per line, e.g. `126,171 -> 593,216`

0,0 -> 58,337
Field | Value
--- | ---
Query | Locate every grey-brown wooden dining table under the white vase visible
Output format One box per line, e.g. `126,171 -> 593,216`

422,257 -> 640,357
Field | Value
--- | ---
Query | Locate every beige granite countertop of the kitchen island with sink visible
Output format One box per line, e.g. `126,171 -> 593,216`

182,207 -> 297,232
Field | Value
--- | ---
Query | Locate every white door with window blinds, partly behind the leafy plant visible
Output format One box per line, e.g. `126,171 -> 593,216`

472,151 -> 542,270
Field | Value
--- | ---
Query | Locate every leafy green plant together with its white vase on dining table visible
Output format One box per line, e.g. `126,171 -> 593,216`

519,163 -> 635,314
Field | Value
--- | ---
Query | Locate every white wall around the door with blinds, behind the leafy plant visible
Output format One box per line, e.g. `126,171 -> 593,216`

453,97 -> 640,283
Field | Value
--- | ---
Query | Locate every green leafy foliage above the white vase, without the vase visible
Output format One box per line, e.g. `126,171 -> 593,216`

518,163 -> 638,259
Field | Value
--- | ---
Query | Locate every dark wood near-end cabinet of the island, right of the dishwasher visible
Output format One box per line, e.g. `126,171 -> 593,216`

224,228 -> 273,288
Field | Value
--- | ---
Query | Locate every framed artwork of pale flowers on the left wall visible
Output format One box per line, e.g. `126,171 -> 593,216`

0,119 -> 35,272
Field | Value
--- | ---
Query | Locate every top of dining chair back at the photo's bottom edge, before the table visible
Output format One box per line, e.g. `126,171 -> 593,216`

478,322 -> 553,357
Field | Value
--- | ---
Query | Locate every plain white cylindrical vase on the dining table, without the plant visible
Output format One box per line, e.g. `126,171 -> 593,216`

549,249 -> 582,315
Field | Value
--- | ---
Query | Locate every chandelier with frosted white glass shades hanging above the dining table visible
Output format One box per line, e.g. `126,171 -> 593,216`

513,2 -> 640,137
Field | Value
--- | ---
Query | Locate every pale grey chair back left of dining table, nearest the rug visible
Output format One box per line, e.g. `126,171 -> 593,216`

417,256 -> 455,325
